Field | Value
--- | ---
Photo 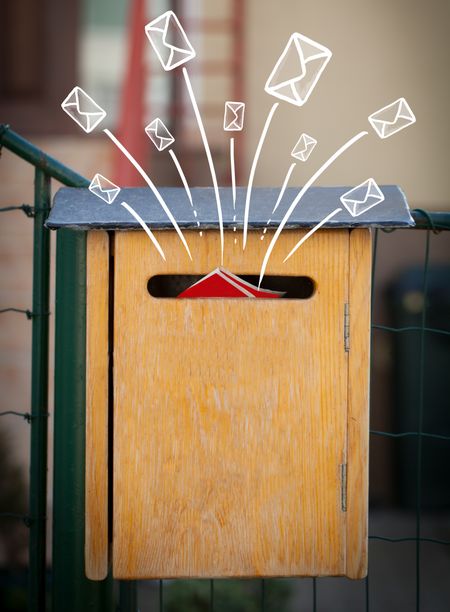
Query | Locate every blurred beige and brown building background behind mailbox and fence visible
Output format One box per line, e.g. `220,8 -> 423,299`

0,0 -> 450,610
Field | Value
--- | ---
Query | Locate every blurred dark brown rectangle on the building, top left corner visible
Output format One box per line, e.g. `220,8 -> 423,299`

0,0 -> 79,135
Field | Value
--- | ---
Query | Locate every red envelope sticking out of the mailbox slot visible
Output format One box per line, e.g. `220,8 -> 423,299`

178,268 -> 284,299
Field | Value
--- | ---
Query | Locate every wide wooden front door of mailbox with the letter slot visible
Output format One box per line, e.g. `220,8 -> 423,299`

113,230 -> 349,578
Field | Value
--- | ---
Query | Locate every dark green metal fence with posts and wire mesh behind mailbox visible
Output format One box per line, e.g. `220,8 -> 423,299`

0,125 -> 450,612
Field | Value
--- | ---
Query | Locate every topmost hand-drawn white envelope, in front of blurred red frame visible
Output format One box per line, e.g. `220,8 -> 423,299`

145,11 -> 195,70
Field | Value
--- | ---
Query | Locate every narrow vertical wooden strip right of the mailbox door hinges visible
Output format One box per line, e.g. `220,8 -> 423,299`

346,229 -> 372,578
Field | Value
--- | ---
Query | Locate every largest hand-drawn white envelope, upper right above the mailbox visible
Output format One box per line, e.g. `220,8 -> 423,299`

264,33 -> 333,106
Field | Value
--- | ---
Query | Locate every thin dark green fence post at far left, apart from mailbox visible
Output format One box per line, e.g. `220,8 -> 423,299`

28,169 -> 50,612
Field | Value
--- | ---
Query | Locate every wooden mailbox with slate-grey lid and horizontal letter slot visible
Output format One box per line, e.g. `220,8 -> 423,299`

48,187 -> 413,580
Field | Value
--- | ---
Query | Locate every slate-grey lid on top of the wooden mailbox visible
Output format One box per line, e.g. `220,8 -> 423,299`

47,185 -> 414,230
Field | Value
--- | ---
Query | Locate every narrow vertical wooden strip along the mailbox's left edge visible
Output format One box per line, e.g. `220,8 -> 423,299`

85,231 -> 109,580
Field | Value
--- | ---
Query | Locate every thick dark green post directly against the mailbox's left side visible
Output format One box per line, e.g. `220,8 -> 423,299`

53,230 -> 114,612
